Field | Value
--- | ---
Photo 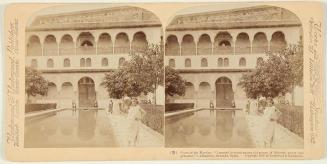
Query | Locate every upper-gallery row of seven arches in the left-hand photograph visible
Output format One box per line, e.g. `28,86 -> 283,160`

26,31 -> 148,56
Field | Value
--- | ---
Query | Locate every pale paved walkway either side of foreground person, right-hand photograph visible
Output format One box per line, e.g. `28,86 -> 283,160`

245,114 -> 304,149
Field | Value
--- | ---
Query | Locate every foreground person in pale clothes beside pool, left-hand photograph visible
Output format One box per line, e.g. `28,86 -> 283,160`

127,98 -> 145,146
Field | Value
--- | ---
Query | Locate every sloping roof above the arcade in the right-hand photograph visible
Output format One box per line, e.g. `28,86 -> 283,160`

167,6 -> 301,31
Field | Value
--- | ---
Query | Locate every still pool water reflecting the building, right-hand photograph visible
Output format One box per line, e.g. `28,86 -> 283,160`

165,110 -> 254,148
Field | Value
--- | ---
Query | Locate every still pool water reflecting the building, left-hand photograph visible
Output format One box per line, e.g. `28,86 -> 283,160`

24,109 -> 117,147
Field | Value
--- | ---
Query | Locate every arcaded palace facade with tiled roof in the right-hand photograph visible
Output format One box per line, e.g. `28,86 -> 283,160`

165,6 -> 303,108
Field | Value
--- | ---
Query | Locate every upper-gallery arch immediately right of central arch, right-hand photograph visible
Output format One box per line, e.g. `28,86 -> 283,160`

235,32 -> 251,54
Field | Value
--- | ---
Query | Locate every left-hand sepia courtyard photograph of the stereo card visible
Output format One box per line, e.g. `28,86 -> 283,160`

24,4 -> 164,148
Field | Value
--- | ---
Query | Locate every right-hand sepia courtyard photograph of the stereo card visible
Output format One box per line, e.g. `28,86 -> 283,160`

165,4 -> 304,149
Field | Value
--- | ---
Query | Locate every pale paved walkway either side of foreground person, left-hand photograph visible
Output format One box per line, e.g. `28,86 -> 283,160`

108,114 -> 164,147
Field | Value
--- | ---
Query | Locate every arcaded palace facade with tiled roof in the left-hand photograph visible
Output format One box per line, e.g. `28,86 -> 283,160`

25,6 -> 164,108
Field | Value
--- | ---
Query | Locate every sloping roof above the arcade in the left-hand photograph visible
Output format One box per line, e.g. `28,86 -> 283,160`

27,7 -> 161,31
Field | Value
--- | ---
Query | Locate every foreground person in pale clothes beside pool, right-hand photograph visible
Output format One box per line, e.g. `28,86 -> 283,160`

262,98 -> 281,148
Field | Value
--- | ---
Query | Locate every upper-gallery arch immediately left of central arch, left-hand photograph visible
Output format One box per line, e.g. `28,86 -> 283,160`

59,34 -> 75,55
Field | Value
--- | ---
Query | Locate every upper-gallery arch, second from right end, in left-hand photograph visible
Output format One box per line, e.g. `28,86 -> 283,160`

114,32 -> 130,54
